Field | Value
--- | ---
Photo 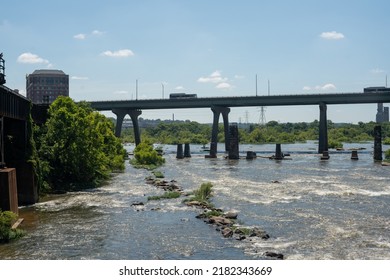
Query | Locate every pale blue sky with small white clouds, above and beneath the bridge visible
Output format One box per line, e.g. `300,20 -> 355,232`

0,0 -> 390,123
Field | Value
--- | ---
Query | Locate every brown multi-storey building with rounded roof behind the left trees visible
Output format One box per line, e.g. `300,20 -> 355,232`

26,69 -> 69,104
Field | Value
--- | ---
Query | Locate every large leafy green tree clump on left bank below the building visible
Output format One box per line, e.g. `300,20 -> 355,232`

34,97 -> 126,192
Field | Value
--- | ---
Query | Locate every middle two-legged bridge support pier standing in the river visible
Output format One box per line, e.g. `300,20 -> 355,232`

208,107 -> 230,158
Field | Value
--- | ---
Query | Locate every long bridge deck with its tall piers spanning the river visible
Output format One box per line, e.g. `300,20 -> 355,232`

89,92 -> 390,157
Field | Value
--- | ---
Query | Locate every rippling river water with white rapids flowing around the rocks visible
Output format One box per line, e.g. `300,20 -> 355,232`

0,143 -> 390,260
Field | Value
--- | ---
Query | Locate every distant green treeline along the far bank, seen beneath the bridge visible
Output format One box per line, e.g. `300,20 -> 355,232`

122,120 -> 390,148
